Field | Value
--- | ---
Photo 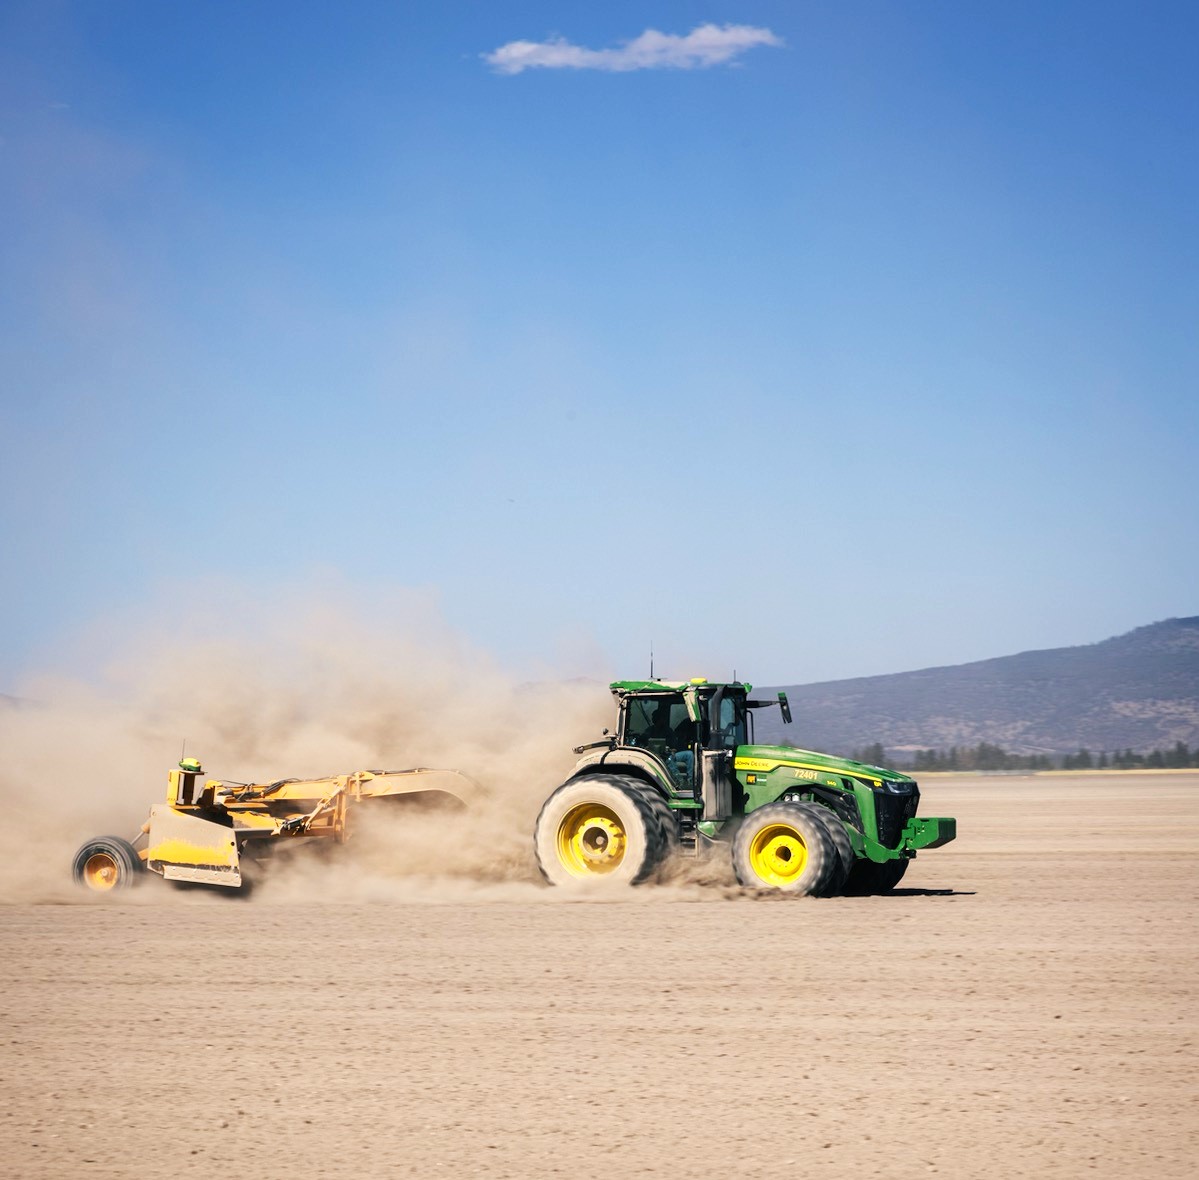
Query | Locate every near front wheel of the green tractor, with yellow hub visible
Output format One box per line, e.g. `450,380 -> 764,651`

733,802 -> 839,897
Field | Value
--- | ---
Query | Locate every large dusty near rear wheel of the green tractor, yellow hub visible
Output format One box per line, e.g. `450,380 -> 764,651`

534,775 -> 665,887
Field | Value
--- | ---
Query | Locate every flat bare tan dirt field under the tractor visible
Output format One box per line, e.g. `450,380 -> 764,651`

0,775 -> 1199,1180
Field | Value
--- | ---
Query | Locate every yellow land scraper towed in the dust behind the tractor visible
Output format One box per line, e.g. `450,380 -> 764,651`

73,758 -> 478,893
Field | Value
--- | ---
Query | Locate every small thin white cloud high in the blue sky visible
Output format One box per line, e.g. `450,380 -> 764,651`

483,24 -> 783,74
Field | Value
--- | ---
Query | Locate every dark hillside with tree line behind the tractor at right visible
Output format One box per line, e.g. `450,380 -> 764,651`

755,616 -> 1199,754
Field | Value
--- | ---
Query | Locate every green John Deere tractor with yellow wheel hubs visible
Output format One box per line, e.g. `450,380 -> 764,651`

534,680 -> 957,897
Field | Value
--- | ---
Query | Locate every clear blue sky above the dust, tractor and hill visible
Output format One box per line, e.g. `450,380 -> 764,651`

0,0 -> 1199,691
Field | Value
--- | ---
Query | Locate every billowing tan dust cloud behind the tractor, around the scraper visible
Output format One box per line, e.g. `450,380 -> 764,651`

0,588 -> 611,904
